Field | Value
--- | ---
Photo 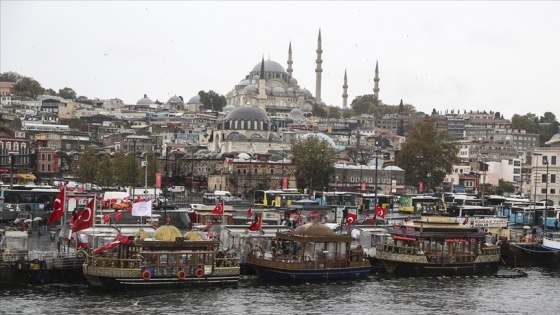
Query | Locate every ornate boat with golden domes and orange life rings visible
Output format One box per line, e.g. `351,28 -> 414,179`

81,225 -> 240,289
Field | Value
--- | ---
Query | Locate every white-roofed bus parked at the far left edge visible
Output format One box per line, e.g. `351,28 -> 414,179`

1,188 -> 60,211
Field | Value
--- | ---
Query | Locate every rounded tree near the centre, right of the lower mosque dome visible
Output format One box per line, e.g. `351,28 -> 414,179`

292,136 -> 337,190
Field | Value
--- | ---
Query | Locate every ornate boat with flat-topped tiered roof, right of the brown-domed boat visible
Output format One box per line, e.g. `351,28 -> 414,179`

376,213 -> 500,276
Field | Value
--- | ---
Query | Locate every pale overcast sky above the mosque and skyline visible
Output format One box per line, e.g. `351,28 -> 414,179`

0,0 -> 560,118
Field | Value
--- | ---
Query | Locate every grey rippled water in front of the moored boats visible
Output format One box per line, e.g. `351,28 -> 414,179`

0,268 -> 560,315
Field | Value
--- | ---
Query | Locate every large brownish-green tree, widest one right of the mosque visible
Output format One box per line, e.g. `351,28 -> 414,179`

396,117 -> 460,187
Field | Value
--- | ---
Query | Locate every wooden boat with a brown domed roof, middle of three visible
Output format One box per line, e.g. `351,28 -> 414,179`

246,220 -> 371,281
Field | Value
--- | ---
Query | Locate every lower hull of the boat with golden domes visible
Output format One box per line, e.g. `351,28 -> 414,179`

83,264 -> 240,289
